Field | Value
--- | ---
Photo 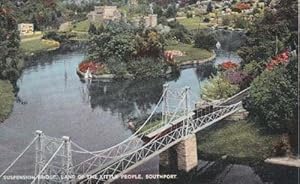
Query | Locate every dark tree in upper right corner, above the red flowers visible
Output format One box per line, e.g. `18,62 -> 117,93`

238,0 -> 298,65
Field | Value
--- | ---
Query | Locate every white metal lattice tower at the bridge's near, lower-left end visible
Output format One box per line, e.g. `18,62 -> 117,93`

32,130 -> 75,184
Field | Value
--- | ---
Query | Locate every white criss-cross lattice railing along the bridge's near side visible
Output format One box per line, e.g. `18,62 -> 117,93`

81,102 -> 241,183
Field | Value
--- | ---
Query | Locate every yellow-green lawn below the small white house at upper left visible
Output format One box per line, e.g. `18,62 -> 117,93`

21,39 -> 60,53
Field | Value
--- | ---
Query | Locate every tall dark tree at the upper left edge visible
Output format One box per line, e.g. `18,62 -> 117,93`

0,0 -> 22,82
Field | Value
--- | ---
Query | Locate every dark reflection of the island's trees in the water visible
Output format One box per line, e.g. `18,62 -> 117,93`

88,77 -> 180,121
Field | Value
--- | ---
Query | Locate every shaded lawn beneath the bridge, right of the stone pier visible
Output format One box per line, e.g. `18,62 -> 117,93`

197,120 -> 280,159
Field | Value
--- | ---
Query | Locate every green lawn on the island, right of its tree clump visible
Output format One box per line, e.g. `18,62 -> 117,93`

166,43 -> 213,63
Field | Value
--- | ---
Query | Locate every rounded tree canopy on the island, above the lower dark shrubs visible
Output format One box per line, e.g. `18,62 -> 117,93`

88,22 -> 164,62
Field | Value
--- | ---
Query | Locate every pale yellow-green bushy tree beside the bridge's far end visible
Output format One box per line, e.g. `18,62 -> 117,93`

202,74 -> 239,100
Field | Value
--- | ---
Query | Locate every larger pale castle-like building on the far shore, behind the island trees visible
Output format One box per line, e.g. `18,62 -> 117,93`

87,6 -> 121,22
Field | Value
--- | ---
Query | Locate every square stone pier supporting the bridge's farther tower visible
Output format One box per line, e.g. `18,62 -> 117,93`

159,134 -> 198,172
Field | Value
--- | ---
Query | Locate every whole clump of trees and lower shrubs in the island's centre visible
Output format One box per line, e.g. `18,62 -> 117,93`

88,21 -> 170,77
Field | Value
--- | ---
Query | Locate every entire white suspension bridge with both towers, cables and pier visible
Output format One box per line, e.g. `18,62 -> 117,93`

0,85 -> 247,184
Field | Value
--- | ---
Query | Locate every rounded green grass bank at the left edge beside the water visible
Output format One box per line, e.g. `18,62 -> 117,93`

0,80 -> 15,122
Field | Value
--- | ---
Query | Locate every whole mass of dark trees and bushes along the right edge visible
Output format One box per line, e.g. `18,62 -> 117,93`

239,0 -> 298,132
